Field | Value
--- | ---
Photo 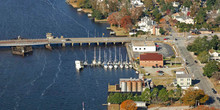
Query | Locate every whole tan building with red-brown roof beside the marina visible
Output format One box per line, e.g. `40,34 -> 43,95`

140,53 -> 163,67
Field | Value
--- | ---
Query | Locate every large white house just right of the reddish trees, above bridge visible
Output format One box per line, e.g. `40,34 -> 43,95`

137,16 -> 156,34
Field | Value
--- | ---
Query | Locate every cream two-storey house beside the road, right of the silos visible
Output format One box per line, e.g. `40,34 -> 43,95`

176,72 -> 192,87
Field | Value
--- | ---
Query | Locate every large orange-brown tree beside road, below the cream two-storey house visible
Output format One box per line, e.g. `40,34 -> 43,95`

181,89 -> 209,106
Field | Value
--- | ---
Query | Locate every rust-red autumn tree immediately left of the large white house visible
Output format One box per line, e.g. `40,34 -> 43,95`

120,16 -> 132,30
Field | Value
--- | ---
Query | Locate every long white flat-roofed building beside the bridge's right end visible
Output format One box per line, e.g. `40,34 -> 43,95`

131,40 -> 156,52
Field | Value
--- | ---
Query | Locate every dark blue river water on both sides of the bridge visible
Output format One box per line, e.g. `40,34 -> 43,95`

0,0 -> 137,110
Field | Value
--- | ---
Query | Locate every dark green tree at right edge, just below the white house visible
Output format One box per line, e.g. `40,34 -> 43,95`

203,61 -> 219,77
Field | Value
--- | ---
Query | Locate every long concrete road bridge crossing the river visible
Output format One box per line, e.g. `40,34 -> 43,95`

0,37 -> 144,47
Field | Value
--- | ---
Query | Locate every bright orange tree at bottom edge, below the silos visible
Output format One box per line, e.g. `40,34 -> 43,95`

120,100 -> 137,110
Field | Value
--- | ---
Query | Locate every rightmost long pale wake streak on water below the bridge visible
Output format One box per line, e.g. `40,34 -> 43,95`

41,51 -> 62,97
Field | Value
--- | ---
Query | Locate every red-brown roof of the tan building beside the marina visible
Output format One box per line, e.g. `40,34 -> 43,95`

140,53 -> 163,61
